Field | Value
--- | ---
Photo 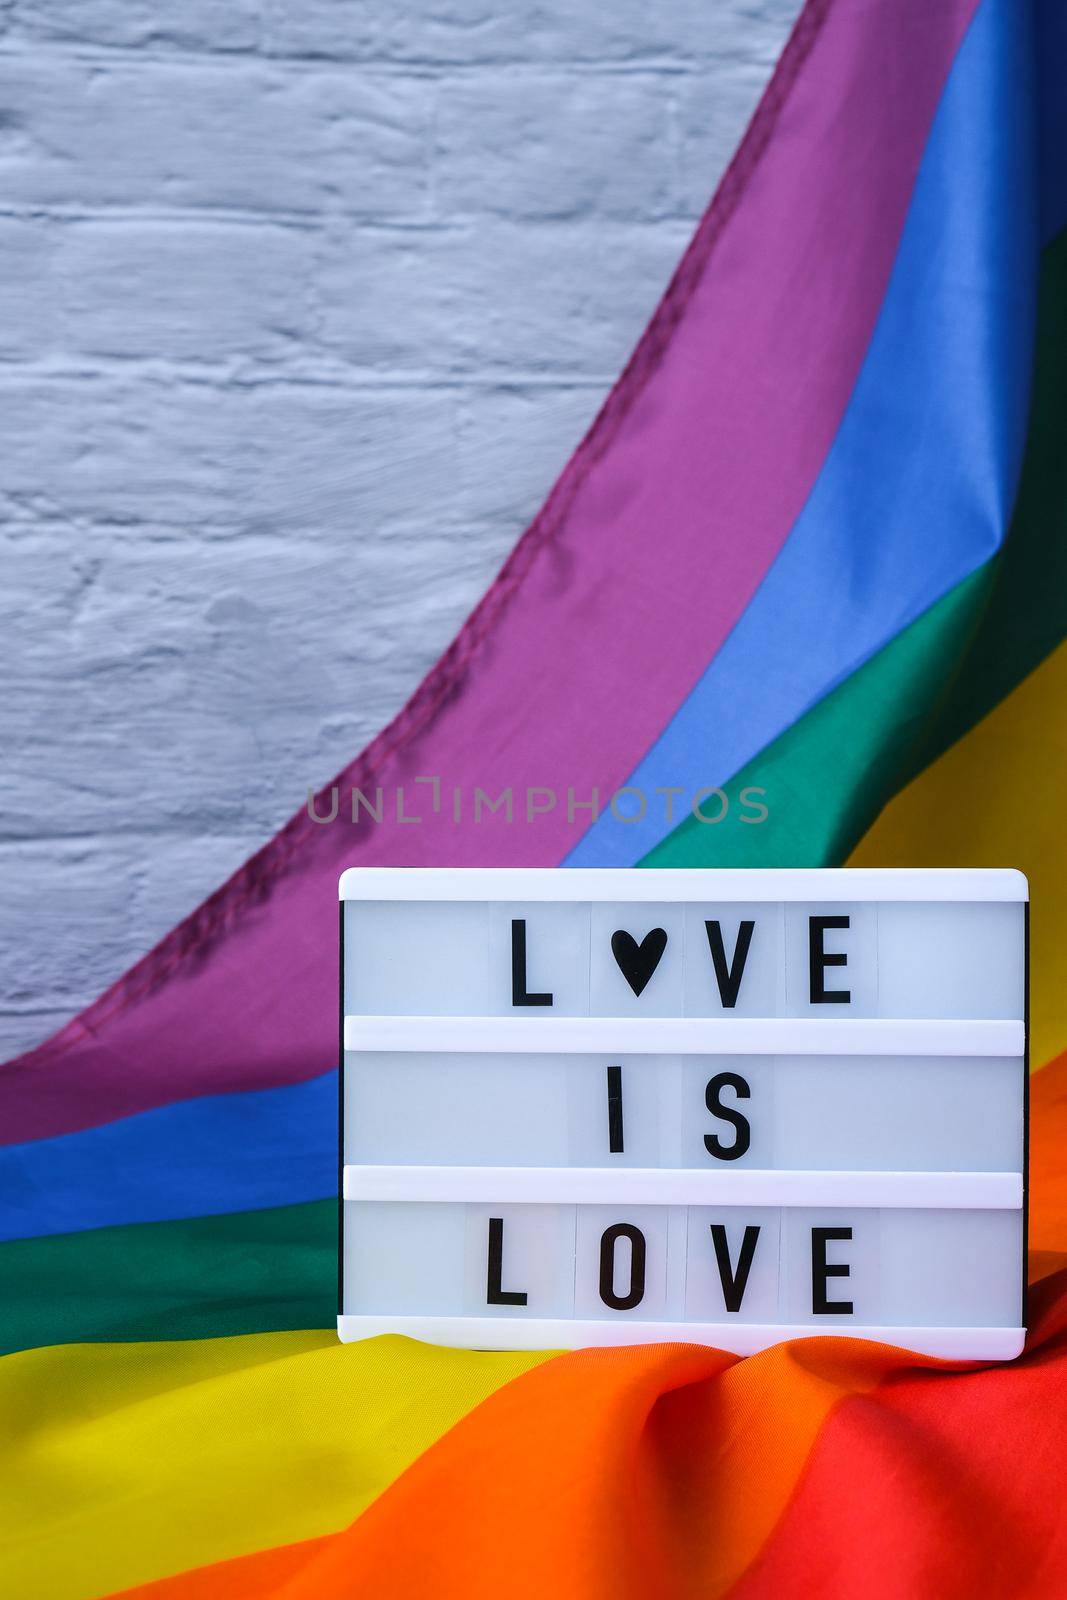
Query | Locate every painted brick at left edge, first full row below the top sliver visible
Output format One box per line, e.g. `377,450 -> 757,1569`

0,56 -> 430,218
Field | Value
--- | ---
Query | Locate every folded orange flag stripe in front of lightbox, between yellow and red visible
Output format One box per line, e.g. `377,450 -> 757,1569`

115,1339 -> 899,1600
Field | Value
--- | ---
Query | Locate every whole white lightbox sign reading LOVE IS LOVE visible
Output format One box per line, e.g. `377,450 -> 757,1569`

338,867 -> 1029,1360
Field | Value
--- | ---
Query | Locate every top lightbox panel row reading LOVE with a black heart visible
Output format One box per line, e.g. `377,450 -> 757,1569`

346,896 -> 1024,1019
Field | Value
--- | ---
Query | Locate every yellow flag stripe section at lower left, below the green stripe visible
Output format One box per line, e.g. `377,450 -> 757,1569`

0,1331 -> 547,1600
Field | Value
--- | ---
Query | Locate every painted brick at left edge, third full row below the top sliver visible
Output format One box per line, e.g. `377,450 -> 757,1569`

0,373 -> 467,521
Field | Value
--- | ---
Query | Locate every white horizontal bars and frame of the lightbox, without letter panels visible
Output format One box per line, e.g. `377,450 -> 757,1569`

338,867 -> 1029,1362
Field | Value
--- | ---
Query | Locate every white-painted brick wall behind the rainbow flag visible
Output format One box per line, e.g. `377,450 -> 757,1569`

0,0 -> 798,1054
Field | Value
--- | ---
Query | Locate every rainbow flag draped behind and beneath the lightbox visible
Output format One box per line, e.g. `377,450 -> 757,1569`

0,0 -> 1067,1600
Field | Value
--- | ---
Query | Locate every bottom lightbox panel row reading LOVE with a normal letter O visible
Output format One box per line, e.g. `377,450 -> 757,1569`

342,1202 -> 1022,1347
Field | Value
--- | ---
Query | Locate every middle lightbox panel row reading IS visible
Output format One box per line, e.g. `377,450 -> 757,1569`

344,1051 -> 1024,1173
